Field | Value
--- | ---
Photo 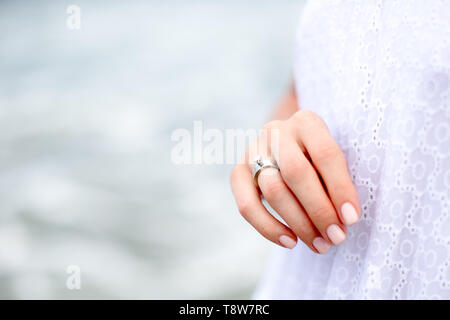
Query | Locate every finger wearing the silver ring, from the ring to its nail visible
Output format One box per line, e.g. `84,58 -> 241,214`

258,168 -> 330,253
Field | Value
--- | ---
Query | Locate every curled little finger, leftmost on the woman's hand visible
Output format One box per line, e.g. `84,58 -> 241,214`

231,164 -> 297,249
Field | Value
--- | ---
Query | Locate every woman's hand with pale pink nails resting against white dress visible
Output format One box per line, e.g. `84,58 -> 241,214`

231,110 -> 360,253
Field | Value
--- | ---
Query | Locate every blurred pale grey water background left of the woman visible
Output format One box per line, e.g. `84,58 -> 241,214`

0,0 -> 303,299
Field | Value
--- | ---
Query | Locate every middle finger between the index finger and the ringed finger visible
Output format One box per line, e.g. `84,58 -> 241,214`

277,135 -> 345,245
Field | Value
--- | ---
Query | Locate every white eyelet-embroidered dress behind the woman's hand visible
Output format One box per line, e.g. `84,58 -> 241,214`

254,0 -> 450,299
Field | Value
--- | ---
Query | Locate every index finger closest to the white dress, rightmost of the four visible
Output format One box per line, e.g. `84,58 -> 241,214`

297,110 -> 361,225
